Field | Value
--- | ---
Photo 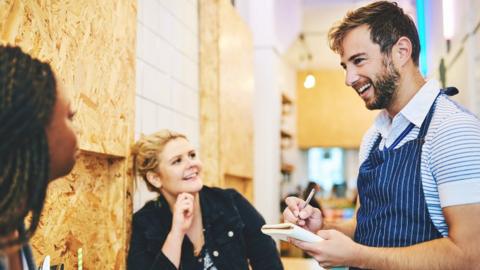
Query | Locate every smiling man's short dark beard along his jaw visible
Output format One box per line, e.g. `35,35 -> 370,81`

365,56 -> 400,110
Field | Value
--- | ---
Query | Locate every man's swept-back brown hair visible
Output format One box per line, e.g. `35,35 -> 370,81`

328,1 -> 420,66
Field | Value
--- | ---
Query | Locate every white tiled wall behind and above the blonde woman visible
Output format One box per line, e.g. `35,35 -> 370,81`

134,0 -> 199,210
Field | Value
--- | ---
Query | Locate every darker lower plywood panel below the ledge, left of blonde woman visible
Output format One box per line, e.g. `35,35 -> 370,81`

31,155 -> 131,269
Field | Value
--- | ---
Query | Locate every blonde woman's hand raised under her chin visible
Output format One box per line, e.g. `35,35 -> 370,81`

171,193 -> 195,235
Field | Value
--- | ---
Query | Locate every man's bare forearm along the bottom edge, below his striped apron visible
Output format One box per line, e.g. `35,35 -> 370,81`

355,238 -> 472,270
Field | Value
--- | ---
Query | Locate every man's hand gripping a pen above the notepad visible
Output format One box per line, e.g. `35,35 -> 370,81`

283,197 -> 323,233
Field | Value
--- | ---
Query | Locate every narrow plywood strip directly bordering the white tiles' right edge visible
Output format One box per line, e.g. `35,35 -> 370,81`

199,0 -> 222,186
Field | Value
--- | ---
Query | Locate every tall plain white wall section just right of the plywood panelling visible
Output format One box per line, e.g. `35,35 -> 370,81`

235,0 -> 301,223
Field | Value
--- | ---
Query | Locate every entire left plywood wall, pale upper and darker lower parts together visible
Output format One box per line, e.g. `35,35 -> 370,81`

0,0 -> 136,269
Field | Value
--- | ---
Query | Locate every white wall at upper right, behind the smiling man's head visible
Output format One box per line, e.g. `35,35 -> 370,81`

426,0 -> 480,115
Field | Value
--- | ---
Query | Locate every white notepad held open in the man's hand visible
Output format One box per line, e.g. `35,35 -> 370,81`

261,223 -> 323,243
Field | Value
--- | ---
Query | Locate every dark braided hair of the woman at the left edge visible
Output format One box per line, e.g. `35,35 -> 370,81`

0,45 -> 56,249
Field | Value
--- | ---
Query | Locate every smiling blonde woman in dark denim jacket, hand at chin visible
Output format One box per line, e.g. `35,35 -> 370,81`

128,130 -> 283,270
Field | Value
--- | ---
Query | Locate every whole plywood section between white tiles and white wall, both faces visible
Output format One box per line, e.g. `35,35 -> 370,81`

199,0 -> 254,200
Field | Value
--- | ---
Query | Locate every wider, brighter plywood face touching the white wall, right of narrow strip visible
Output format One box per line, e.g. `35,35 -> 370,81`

219,1 -> 254,179
